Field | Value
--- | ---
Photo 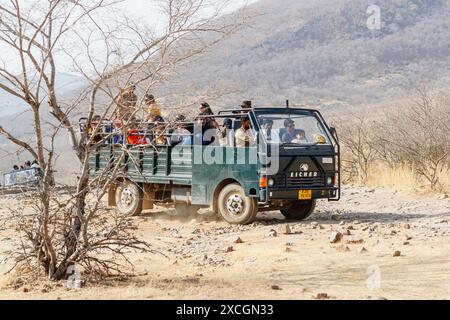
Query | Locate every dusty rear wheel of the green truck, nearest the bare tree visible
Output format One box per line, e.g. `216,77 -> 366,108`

116,181 -> 144,216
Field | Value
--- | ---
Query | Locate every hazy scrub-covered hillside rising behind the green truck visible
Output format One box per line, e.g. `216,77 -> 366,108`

164,0 -> 450,109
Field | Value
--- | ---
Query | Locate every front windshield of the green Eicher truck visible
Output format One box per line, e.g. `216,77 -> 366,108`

258,113 -> 331,145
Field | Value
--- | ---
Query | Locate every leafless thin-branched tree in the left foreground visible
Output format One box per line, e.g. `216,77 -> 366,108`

0,0 -> 248,279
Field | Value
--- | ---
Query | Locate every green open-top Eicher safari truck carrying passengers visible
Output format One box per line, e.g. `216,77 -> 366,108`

90,107 -> 341,224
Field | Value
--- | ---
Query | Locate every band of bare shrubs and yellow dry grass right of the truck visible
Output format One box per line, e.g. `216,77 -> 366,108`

337,88 -> 450,192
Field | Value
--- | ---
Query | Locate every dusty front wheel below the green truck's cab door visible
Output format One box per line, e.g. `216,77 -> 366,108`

217,184 -> 258,225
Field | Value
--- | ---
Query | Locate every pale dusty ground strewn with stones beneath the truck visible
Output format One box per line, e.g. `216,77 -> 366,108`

0,188 -> 450,299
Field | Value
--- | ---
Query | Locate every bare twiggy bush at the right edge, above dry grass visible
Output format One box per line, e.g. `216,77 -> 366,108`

379,87 -> 450,189
